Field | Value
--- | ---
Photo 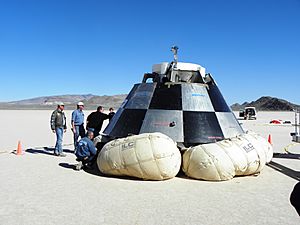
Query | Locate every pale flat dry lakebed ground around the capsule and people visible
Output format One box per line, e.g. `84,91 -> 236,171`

0,110 -> 300,225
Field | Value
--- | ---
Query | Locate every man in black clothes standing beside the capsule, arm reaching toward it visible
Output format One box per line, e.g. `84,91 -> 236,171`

86,106 -> 109,137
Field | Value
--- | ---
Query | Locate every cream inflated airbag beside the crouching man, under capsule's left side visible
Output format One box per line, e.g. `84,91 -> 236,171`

97,133 -> 181,180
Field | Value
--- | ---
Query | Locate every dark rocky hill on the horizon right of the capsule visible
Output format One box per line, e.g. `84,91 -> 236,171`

231,96 -> 300,111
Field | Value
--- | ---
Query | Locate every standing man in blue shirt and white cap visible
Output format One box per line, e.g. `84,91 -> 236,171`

71,102 -> 85,152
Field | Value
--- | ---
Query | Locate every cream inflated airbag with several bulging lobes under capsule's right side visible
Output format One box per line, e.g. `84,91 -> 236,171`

182,132 -> 273,181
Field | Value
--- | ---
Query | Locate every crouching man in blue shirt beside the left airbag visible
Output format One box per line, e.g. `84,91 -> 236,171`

75,131 -> 97,170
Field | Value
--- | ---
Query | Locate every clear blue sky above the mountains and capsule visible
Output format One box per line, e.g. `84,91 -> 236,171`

0,0 -> 300,104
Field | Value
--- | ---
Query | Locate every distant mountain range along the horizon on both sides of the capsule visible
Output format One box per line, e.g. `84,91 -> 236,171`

0,94 -> 300,111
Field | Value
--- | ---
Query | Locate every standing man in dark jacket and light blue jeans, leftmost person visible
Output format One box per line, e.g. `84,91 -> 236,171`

50,102 -> 67,157
